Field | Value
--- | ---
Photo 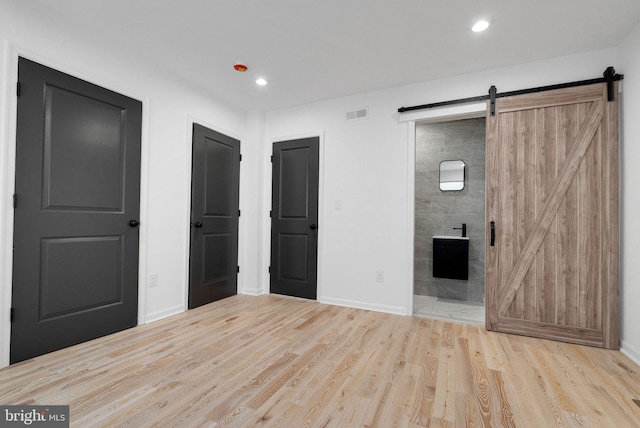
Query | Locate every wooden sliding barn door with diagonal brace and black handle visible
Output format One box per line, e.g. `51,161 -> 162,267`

486,84 -> 619,349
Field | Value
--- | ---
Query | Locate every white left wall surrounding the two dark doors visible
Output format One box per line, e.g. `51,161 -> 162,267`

0,2 -> 245,367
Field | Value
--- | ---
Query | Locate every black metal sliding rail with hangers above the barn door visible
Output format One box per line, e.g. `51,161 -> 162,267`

398,67 -> 624,116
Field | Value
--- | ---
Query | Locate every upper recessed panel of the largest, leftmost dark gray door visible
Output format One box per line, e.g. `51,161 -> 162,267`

43,86 -> 125,211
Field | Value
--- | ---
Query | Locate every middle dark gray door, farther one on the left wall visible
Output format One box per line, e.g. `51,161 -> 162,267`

189,124 -> 240,308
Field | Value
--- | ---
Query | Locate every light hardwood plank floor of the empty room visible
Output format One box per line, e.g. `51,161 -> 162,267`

0,295 -> 640,428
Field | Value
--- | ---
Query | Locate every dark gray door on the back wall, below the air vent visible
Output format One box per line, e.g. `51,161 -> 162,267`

270,137 -> 319,299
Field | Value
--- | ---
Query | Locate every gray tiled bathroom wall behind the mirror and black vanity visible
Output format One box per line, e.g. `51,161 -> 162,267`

414,118 -> 486,302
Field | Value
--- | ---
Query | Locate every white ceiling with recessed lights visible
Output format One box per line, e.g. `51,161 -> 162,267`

11,0 -> 640,110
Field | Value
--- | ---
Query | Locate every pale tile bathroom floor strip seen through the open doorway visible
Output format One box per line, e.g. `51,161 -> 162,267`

413,295 -> 484,325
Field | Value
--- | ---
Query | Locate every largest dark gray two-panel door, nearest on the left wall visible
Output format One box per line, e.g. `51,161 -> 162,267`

11,58 -> 142,363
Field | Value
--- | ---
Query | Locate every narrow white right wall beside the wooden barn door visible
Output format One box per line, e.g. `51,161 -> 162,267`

620,25 -> 640,364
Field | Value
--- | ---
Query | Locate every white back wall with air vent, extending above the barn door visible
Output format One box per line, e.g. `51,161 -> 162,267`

262,47 -> 640,343
